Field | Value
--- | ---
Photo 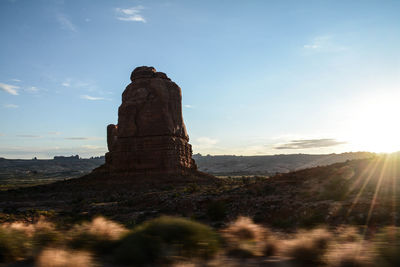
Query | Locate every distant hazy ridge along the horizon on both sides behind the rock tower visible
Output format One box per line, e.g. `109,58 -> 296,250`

0,152 -> 375,188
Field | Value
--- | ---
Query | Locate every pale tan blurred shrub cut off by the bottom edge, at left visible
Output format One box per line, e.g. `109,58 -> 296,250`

36,248 -> 94,267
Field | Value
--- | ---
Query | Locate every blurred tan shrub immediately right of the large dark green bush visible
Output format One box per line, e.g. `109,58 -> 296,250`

221,217 -> 268,258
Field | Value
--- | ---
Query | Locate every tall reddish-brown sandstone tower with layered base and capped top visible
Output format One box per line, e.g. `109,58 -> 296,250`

105,66 -> 197,174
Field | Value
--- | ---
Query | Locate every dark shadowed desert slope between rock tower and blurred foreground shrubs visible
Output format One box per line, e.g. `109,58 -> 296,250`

0,154 -> 400,227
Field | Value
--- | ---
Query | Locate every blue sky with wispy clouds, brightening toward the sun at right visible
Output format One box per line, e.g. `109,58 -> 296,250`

0,0 -> 400,158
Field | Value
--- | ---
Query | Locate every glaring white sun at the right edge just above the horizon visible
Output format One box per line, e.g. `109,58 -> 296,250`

343,94 -> 400,153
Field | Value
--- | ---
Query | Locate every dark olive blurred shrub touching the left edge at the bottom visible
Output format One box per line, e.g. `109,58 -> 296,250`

0,227 -> 31,262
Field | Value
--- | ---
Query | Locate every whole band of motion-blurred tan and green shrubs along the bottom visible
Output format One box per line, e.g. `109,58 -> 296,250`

0,216 -> 400,267
